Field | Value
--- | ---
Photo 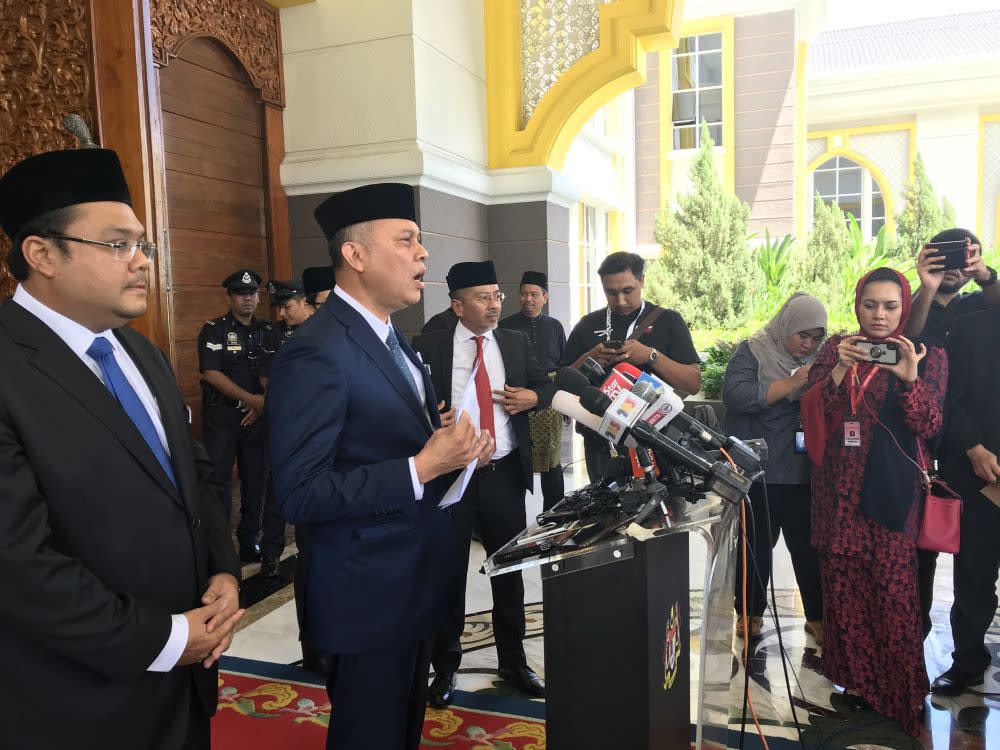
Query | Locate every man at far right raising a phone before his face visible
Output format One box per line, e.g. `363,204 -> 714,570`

906,227 -> 1000,346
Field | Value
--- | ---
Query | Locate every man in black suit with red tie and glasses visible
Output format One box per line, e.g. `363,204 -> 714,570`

413,261 -> 555,708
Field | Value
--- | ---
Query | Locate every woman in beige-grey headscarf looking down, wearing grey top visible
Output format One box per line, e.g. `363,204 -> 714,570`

722,292 -> 827,644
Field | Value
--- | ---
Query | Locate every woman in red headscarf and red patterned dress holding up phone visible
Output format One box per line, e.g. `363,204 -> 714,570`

802,268 -> 948,735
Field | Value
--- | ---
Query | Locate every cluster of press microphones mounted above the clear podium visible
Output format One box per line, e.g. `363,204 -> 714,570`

552,358 -> 767,502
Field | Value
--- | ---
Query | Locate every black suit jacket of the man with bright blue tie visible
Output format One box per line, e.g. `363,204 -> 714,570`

0,300 -> 239,748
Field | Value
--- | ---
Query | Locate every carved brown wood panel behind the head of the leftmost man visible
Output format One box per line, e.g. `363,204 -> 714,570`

0,0 -> 95,298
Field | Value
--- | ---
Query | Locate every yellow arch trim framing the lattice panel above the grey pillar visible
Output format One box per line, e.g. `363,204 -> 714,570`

484,0 -> 684,169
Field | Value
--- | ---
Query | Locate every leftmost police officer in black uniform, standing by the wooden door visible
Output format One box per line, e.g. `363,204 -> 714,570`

198,269 -> 271,562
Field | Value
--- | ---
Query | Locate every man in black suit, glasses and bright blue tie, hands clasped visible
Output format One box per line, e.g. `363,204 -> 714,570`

0,149 -> 243,750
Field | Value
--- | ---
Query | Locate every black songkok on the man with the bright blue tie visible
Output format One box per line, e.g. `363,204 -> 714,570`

0,148 -> 132,245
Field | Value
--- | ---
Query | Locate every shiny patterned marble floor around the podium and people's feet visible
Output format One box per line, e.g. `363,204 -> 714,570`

229,434 -> 1000,750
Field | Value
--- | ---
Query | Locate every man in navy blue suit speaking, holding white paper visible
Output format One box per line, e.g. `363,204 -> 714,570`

267,184 -> 494,750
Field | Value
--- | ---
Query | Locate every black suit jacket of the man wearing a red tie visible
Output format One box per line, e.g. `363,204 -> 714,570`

413,328 -> 556,492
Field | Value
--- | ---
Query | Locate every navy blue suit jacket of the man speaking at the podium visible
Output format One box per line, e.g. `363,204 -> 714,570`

267,293 -> 454,654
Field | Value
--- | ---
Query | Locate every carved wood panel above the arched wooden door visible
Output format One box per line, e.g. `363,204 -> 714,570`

149,0 -> 285,107
